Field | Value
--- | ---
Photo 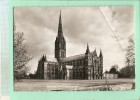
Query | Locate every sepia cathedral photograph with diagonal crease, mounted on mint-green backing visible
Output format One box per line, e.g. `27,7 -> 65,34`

13,6 -> 135,91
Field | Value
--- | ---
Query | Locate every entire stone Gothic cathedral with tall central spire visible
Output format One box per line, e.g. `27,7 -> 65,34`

36,12 -> 103,80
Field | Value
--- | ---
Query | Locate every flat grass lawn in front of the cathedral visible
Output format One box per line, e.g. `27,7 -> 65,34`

14,79 -> 134,91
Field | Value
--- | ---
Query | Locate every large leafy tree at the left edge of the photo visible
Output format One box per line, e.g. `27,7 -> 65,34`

13,25 -> 32,81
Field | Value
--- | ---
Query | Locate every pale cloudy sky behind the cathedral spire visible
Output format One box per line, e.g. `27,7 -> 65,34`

14,6 -> 134,73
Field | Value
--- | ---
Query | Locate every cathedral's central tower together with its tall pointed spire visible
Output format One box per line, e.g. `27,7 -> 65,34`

55,11 -> 66,61
